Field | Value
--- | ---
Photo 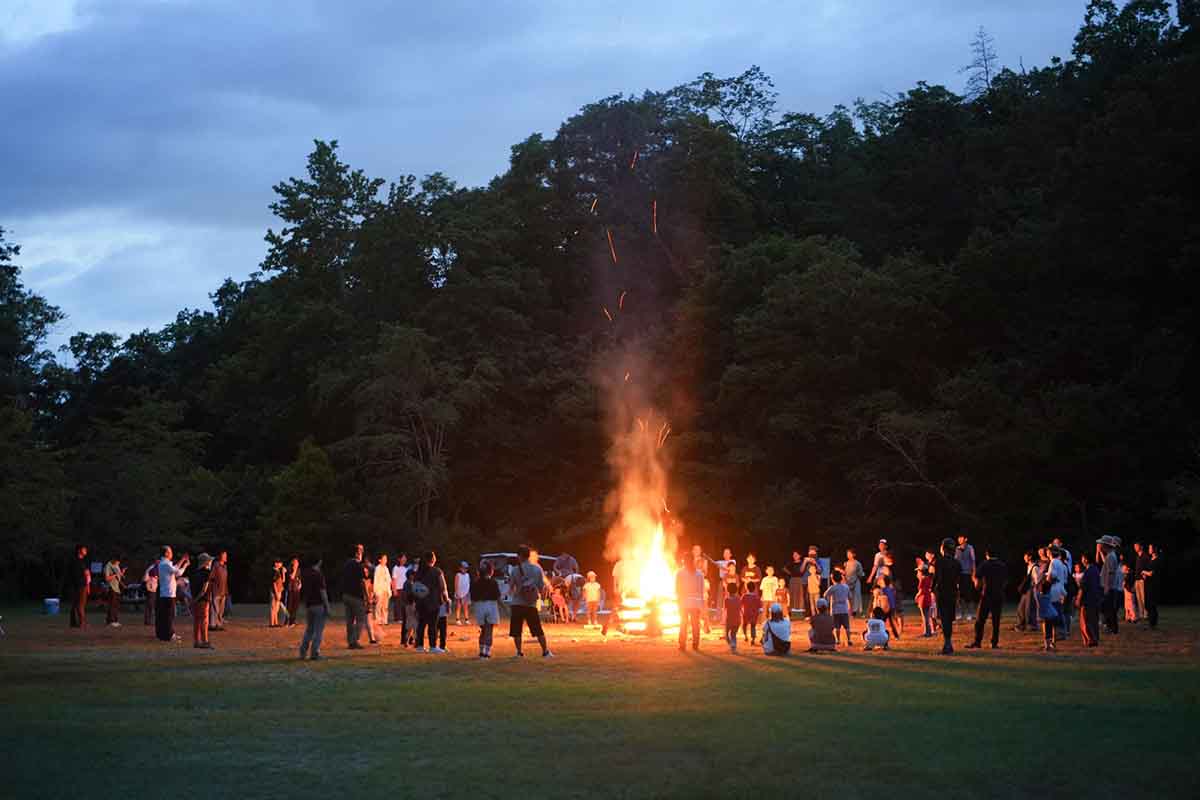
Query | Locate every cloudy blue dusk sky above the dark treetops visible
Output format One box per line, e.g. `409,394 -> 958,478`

0,0 -> 1086,345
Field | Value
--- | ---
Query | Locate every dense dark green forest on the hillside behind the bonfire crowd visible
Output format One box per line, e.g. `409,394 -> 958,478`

0,0 -> 1200,597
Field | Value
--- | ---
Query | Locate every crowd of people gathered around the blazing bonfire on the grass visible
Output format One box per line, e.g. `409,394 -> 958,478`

60,535 -> 1163,660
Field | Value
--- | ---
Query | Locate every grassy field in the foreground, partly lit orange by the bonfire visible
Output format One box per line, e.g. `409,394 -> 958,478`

0,606 -> 1200,800
